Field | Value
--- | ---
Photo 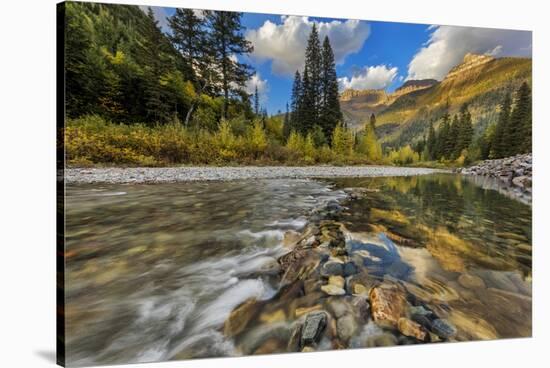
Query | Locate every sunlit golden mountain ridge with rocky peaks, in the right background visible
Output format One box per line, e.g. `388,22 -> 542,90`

340,54 -> 532,145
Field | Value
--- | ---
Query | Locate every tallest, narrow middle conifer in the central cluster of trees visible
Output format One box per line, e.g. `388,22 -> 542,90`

304,23 -> 322,126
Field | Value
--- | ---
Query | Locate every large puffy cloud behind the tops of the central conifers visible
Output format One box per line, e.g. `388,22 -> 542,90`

246,16 -> 370,75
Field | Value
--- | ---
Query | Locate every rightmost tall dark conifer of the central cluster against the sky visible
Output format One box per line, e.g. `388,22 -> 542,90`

319,37 -> 343,142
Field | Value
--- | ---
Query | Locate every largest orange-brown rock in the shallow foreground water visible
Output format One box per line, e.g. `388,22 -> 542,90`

369,283 -> 407,328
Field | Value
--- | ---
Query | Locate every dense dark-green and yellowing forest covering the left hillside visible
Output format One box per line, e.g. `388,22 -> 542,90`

64,3 -> 254,126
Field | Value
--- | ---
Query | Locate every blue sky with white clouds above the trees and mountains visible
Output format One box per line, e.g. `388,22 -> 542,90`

144,7 -> 532,114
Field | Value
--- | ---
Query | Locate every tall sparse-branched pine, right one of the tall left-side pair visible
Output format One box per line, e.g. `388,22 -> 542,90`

206,11 -> 254,118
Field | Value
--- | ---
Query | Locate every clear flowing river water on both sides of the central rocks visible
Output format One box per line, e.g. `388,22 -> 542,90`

65,175 -> 531,365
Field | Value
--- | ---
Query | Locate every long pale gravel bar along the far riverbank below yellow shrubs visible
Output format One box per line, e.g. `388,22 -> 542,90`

65,166 -> 449,184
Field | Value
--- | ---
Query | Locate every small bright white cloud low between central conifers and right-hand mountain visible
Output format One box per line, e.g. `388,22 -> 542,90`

338,65 -> 397,90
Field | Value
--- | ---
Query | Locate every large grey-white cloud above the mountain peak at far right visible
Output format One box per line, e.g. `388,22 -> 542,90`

407,26 -> 532,80
